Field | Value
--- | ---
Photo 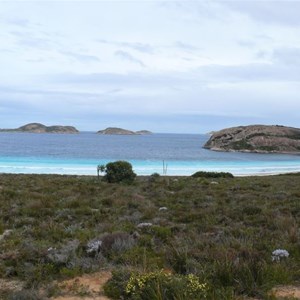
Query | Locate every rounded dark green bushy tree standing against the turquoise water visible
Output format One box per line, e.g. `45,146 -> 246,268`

103,160 -> 136,183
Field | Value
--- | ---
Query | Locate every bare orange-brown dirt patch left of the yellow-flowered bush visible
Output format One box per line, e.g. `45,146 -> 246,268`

51,271 -> 111,300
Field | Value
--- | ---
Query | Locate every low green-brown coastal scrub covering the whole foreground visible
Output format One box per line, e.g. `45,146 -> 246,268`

0,174 -> 300,299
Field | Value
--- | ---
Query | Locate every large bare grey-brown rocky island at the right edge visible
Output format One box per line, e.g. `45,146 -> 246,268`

203,125 -> 300,153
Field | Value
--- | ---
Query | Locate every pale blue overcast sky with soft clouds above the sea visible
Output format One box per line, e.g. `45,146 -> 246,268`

0,0 -> 300,133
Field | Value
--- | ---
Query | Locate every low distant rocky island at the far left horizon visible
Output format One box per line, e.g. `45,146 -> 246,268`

0,123 -> 79,133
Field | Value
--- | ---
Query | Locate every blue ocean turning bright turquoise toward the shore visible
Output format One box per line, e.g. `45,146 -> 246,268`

0,132 -> 300,176
